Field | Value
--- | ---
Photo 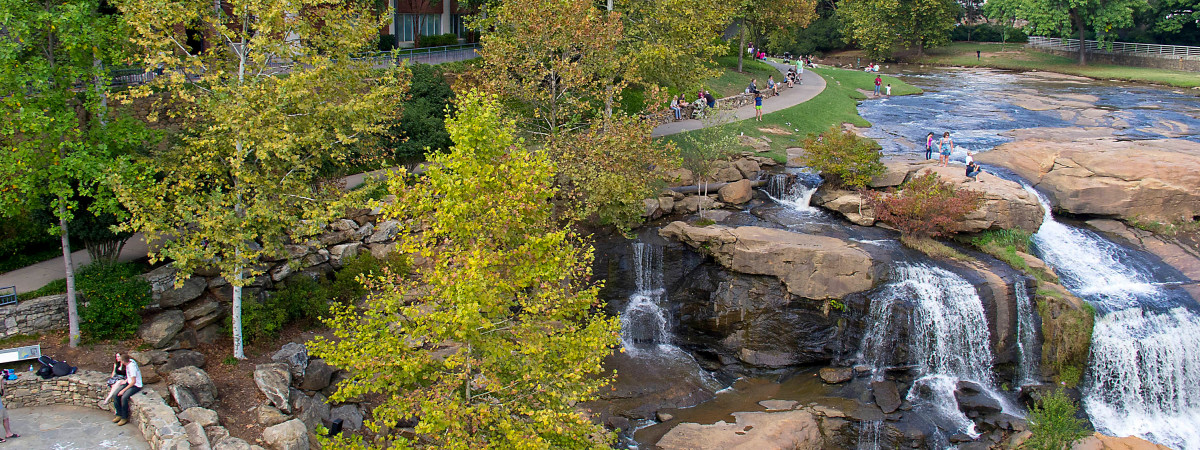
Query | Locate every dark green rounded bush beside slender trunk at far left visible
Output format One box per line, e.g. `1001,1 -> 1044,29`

76,263 -> 150,341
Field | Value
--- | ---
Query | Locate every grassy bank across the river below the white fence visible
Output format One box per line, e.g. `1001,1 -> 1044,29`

905,42 -> 1200,88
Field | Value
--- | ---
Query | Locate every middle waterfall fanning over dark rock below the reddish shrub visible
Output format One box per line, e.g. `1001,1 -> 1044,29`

859,264 -> 995,436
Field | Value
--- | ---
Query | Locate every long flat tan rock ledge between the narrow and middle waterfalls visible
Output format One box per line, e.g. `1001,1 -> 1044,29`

659,222 -> 878,300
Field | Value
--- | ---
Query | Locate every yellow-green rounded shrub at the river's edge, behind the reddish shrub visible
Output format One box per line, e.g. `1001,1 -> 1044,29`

803,125 -> 883,187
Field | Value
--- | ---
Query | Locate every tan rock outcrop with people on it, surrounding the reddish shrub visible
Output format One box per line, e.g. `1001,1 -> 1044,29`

812,160 -> 1043,233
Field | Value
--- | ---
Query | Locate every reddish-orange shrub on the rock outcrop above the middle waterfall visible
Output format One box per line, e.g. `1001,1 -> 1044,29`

865,170 -> 982,238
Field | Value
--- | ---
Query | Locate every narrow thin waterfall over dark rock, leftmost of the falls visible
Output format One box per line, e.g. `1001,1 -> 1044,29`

620,242 -> 671,355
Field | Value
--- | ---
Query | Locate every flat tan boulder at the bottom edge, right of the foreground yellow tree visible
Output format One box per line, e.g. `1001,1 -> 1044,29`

658,410 -> 823,450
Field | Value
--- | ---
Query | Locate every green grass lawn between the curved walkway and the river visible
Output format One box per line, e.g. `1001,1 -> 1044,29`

664,67 -> 922,162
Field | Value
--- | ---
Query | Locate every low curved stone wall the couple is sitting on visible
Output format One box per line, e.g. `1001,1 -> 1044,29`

4,371 -> 191,450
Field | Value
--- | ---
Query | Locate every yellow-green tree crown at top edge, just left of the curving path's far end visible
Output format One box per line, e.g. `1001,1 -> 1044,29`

614,0 -> 734,92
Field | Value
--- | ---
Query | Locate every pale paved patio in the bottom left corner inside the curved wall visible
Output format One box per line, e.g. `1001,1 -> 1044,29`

7,406 -> 150,450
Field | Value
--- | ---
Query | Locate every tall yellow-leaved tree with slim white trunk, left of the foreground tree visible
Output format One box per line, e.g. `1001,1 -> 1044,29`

119,0 -> 407,359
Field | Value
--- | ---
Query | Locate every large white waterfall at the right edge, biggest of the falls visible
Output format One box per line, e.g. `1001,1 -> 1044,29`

1025,185 -> 1200,450
